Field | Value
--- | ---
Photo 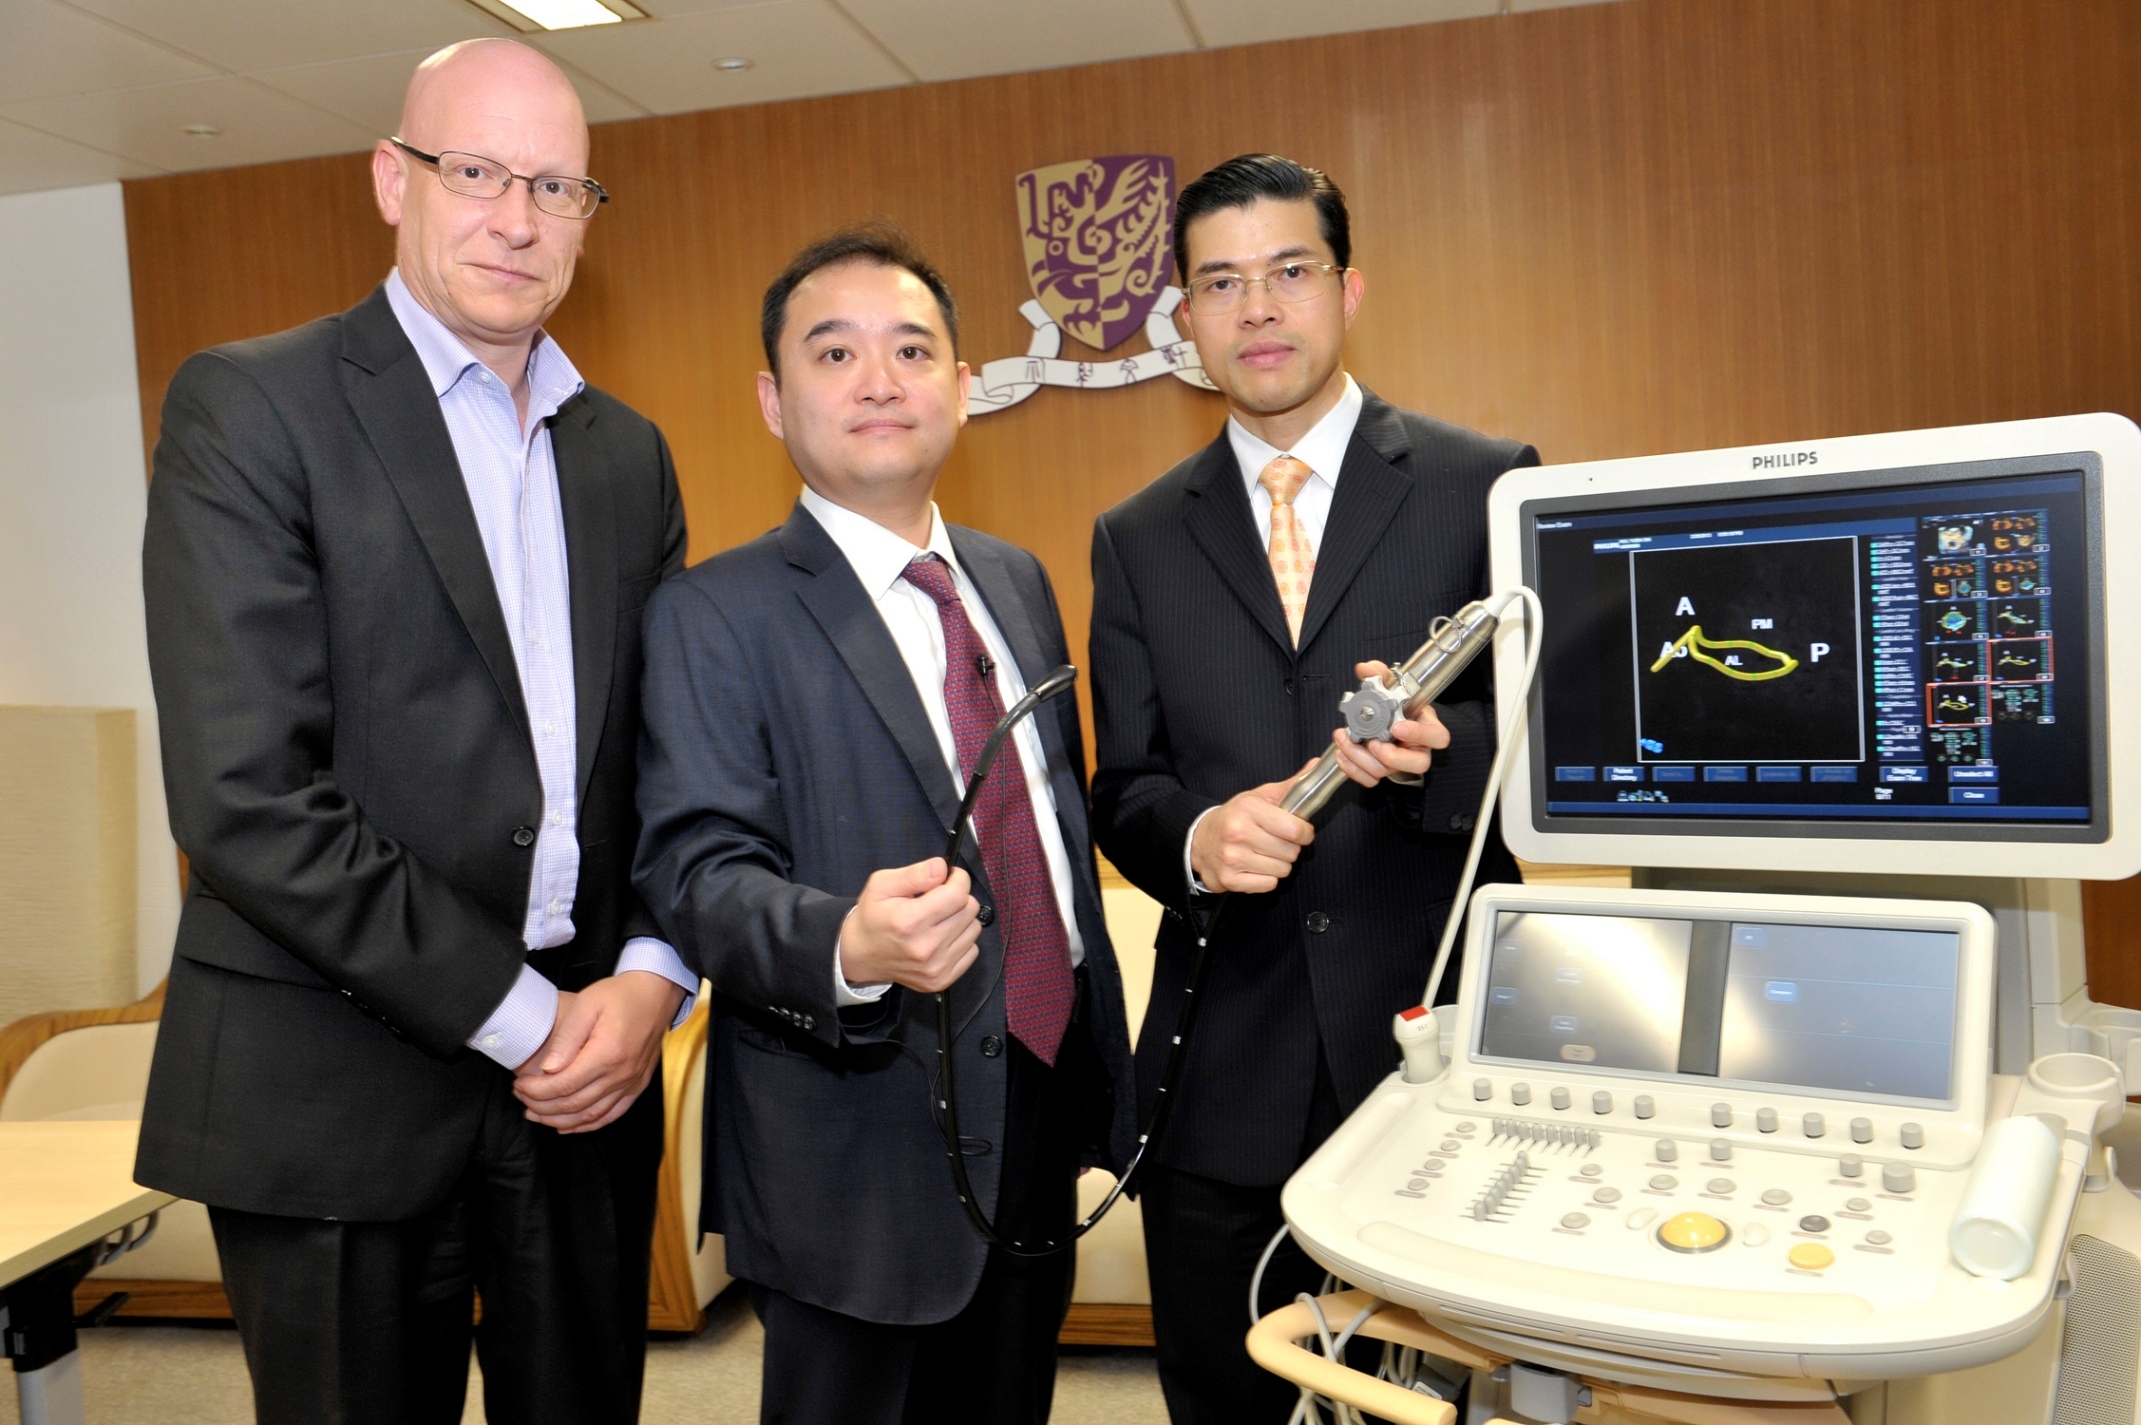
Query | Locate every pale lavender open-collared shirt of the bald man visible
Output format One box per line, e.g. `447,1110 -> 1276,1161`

388,267 -> 698,1068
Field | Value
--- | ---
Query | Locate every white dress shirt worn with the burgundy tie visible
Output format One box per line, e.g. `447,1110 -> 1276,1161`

803,486 -> 1085,1006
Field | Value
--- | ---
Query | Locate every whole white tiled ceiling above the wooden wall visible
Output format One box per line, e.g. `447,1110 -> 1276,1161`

0,0 -> 1597,193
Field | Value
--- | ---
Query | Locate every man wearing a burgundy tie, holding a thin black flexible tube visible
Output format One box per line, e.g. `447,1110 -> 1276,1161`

636,229 -> 1133,1425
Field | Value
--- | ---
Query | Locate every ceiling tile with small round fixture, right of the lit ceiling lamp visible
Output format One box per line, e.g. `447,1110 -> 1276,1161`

537,0 -> 908,113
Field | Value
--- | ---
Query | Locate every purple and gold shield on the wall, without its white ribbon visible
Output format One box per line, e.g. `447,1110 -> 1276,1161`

1019,154 -> 1175,351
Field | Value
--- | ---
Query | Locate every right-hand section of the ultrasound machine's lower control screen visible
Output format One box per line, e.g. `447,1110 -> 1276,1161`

1717,924 -> 1961,1100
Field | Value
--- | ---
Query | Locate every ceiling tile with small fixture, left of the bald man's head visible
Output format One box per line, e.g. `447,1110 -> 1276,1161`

0,79 -> 377,171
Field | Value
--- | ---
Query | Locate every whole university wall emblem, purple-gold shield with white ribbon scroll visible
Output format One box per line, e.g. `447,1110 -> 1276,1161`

968,154 -> 1212,415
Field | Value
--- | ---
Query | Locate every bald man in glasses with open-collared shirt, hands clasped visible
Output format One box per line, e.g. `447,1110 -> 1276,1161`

137,41 -> 698,1425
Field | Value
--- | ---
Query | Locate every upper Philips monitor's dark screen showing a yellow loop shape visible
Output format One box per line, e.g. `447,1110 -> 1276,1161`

1524,460 -> 2107,839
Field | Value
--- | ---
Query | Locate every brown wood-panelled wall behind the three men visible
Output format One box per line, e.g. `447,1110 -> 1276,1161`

126,0 -> 2141,997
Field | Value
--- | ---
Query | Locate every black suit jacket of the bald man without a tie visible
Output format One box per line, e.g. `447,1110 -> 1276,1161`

137,289 -> 683,1220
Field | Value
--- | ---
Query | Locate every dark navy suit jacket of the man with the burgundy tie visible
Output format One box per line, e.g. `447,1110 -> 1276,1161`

638,505 -> 1135,1318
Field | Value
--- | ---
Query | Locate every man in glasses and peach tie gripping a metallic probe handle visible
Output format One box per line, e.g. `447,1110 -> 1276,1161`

1092,154 -> 1537,1425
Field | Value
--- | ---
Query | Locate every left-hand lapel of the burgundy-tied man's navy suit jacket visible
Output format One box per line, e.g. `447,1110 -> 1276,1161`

781,505 -> 959,830
